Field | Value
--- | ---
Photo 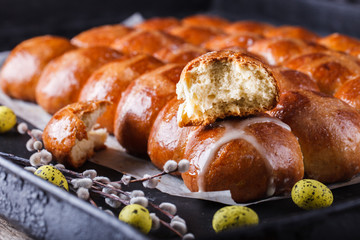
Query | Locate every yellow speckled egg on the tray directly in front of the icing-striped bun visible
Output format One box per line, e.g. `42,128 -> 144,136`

212,206 -> 259,232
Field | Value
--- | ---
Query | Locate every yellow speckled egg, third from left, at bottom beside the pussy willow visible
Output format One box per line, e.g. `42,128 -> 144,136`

119,204 -> 152,234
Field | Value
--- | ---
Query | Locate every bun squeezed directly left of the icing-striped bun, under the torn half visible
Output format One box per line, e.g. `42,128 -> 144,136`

148,97 -> 198,169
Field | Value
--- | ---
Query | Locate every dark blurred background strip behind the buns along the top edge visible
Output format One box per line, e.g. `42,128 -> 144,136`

0,0 -> 360,51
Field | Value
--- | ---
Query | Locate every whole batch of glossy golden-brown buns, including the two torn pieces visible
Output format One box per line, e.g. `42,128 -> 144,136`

0,15 -> 360,202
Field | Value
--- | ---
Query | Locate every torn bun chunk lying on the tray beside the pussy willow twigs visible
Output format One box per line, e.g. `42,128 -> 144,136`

43,101 -> 110,168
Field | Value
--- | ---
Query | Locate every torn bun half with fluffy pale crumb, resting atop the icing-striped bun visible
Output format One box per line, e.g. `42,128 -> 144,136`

176,51 -> 279,127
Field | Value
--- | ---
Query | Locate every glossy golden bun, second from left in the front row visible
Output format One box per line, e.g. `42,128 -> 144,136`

36,47 -> 122,113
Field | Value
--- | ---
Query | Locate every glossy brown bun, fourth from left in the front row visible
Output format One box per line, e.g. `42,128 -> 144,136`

114,64 -> 183,156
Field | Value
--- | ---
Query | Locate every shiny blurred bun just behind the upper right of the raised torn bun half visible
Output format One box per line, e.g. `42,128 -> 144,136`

248,38 -> 327,65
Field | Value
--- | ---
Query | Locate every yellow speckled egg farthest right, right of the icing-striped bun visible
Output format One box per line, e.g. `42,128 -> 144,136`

291,179 -> 333,210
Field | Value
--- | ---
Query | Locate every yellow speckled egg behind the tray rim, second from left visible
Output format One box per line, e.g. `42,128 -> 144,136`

34,165 -> 69,191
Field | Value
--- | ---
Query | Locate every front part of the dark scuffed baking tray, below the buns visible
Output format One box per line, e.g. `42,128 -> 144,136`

0,117 -> 360,239
